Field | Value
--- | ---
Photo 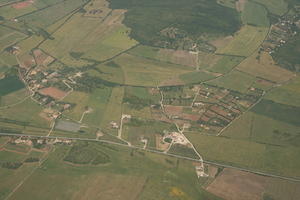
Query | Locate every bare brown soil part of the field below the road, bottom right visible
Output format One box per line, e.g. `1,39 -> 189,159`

206,169 -> 268,200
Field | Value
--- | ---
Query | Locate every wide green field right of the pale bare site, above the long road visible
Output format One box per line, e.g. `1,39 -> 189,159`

186,133 -> 300,177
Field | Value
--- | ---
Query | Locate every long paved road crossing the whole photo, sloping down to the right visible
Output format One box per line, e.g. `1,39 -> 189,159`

0,133 -> 300,182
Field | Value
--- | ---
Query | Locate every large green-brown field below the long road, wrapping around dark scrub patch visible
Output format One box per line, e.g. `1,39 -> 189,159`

1,144 -> 223,200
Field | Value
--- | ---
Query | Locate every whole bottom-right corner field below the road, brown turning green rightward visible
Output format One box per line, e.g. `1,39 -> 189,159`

207,169 -> 299,200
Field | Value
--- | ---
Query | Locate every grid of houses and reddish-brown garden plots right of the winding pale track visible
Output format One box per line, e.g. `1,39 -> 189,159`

193,86 -> 263,132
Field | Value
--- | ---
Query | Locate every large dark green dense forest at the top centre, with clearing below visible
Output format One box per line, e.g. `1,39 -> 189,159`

109,0 -> 241,49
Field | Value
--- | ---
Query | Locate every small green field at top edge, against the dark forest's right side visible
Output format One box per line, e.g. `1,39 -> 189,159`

242,1 -> 270,27
